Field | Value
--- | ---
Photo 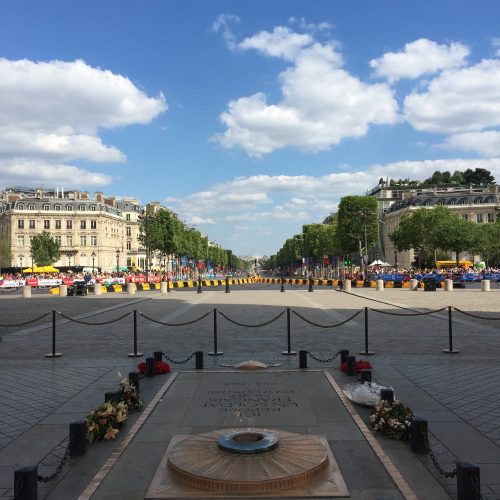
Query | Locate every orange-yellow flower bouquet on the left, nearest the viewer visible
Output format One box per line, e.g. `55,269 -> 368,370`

85,401 -> 127,444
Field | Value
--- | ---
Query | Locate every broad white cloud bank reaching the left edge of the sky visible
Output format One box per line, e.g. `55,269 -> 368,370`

0,58 -> 167,162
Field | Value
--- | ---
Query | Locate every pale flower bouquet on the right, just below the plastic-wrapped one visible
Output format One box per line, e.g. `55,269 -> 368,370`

370,400 -> 413,441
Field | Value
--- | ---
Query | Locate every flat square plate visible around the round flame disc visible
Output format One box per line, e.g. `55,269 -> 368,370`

145,435 -> 349,500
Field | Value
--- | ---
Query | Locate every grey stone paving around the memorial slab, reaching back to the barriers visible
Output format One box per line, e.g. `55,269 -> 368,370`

0,285 -> 500,500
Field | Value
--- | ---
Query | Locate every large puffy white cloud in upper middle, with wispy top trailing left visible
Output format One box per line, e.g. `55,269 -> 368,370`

216,28 -> 398,157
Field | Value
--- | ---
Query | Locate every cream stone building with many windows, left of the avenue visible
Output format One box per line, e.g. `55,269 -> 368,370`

0,188 -> 129,271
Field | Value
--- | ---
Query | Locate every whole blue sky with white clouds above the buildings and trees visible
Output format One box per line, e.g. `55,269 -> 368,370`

0,0 -> 500,256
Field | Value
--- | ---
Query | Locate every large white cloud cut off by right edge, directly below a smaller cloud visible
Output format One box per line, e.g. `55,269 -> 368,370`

404,59 -> 500,134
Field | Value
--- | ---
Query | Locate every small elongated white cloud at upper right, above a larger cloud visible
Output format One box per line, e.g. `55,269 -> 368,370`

370,38 -> 469,82
